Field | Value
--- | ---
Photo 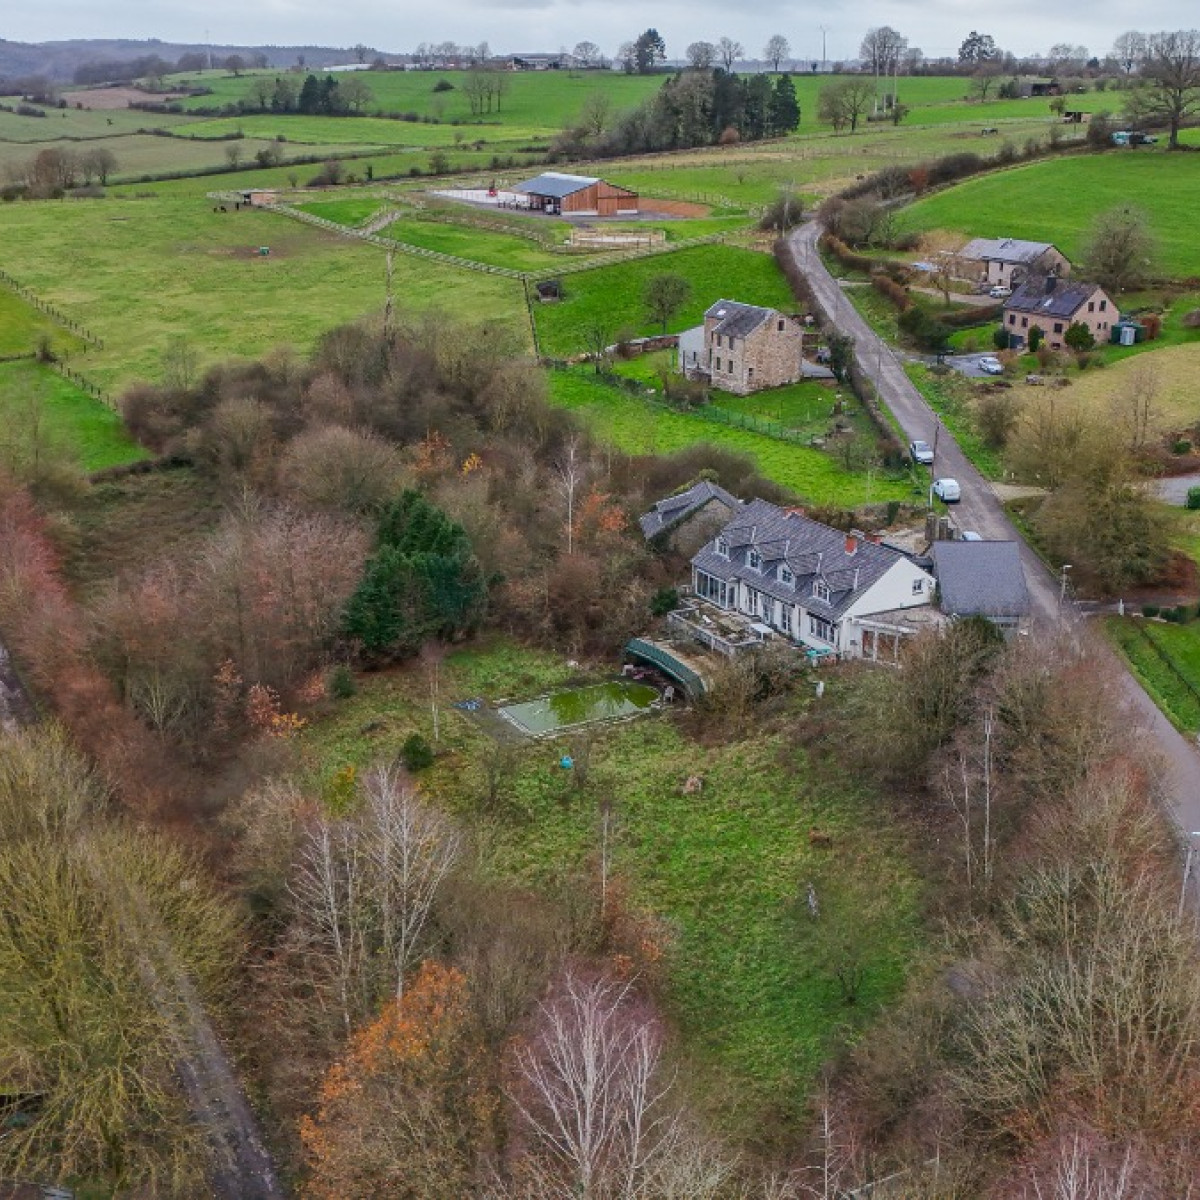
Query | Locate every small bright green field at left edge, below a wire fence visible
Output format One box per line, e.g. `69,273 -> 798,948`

0,362 -> 146,470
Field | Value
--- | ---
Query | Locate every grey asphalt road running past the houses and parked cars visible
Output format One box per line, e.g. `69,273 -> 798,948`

788,221 -> 1200,850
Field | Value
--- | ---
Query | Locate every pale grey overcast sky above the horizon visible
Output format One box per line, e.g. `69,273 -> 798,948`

0,0 -> 1161,60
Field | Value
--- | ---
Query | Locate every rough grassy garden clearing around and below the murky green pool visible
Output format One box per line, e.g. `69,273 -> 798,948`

302,642 -> 920,1136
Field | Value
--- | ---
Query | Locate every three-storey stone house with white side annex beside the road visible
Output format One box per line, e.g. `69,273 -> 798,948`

679,300 -> 804,396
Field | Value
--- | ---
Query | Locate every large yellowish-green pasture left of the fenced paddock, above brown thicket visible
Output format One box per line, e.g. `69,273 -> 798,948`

0,198 -> 528,390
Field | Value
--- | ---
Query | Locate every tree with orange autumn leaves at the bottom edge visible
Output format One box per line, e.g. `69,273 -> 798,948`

300,960 -> 491,1200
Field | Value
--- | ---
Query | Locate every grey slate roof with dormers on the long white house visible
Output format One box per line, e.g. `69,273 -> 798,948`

691,500 -> 905,622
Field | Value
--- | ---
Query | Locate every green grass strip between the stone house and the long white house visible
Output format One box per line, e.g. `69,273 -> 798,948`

550,367 -> 912,508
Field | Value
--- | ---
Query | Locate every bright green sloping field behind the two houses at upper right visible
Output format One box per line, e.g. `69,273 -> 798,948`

900,150 -> 1200,277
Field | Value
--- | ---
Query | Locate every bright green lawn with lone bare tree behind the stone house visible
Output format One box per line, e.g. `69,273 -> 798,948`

534,244 -> 796,358
